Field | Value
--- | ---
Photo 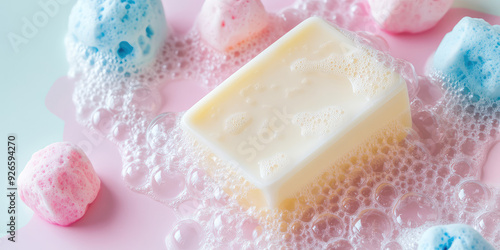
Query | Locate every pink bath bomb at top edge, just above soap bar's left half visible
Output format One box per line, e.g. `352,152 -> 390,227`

196,0 -> 268,51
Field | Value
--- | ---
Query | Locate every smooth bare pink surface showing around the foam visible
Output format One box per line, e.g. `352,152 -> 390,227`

0,0 -> 500,249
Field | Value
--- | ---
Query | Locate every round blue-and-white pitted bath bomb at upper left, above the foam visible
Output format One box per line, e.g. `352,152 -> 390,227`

69,0 -> 167,68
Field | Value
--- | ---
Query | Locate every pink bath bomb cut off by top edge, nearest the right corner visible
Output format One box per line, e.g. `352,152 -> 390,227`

368,0 -> 453,33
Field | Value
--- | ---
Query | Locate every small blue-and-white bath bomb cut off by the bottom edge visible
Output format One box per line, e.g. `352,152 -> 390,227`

418,224 -> 495,250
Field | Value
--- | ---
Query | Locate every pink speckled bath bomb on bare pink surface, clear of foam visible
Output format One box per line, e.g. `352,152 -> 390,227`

17,142 -> 101,226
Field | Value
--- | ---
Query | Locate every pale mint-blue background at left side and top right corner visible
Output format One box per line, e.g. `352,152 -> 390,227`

0,0 -> 500,240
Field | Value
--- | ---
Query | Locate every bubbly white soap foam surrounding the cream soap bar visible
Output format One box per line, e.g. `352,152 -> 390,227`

68,0 -> 500,249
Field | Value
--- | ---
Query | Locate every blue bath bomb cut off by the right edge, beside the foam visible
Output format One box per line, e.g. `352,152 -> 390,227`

434,17 -> 500,100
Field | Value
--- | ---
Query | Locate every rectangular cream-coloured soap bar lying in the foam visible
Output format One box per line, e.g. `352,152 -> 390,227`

182,17 -> 411,208
